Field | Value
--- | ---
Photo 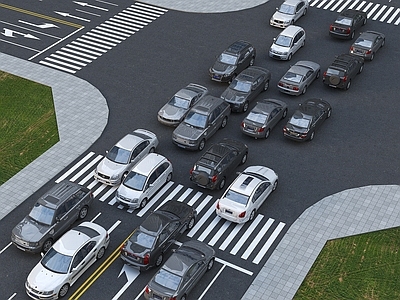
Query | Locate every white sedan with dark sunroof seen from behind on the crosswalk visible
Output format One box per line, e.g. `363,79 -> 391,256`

215,166 -> 278,223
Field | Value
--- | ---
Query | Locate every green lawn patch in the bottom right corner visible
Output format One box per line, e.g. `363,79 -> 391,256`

293,228 -> 400,300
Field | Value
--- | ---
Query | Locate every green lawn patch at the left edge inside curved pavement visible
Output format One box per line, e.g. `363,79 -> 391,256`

0,71 -> 59,185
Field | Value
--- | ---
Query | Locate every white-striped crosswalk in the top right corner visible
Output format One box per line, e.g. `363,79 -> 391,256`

309,0 -> 400,25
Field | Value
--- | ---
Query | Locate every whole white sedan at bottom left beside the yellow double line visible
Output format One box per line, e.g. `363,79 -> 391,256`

25,222 -> 110,300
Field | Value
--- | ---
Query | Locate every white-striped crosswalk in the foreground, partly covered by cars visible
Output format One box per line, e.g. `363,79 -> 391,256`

56,152 -> 286,264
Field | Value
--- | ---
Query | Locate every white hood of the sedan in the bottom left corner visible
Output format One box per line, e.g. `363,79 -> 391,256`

27,262 -> 67,291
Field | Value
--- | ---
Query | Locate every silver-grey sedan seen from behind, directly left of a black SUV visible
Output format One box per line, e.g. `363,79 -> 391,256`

278,60 -> 321,96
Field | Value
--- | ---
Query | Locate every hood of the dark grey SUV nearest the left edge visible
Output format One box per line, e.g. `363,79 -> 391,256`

12,216 -> 50,242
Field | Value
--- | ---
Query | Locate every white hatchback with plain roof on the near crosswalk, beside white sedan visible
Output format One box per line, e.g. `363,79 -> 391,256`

115,153 -> 173,209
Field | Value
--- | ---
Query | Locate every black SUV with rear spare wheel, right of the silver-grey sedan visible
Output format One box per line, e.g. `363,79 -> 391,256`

322,54 -> 364,90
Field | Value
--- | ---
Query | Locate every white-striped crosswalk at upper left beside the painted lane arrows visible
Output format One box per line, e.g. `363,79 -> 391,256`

39,2 -> 168,74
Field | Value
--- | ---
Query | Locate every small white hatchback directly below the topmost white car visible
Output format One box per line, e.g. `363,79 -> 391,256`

269,25 -> 306,60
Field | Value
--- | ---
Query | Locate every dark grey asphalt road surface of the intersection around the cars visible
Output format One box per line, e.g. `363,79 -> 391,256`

0,1 -> 400,299
